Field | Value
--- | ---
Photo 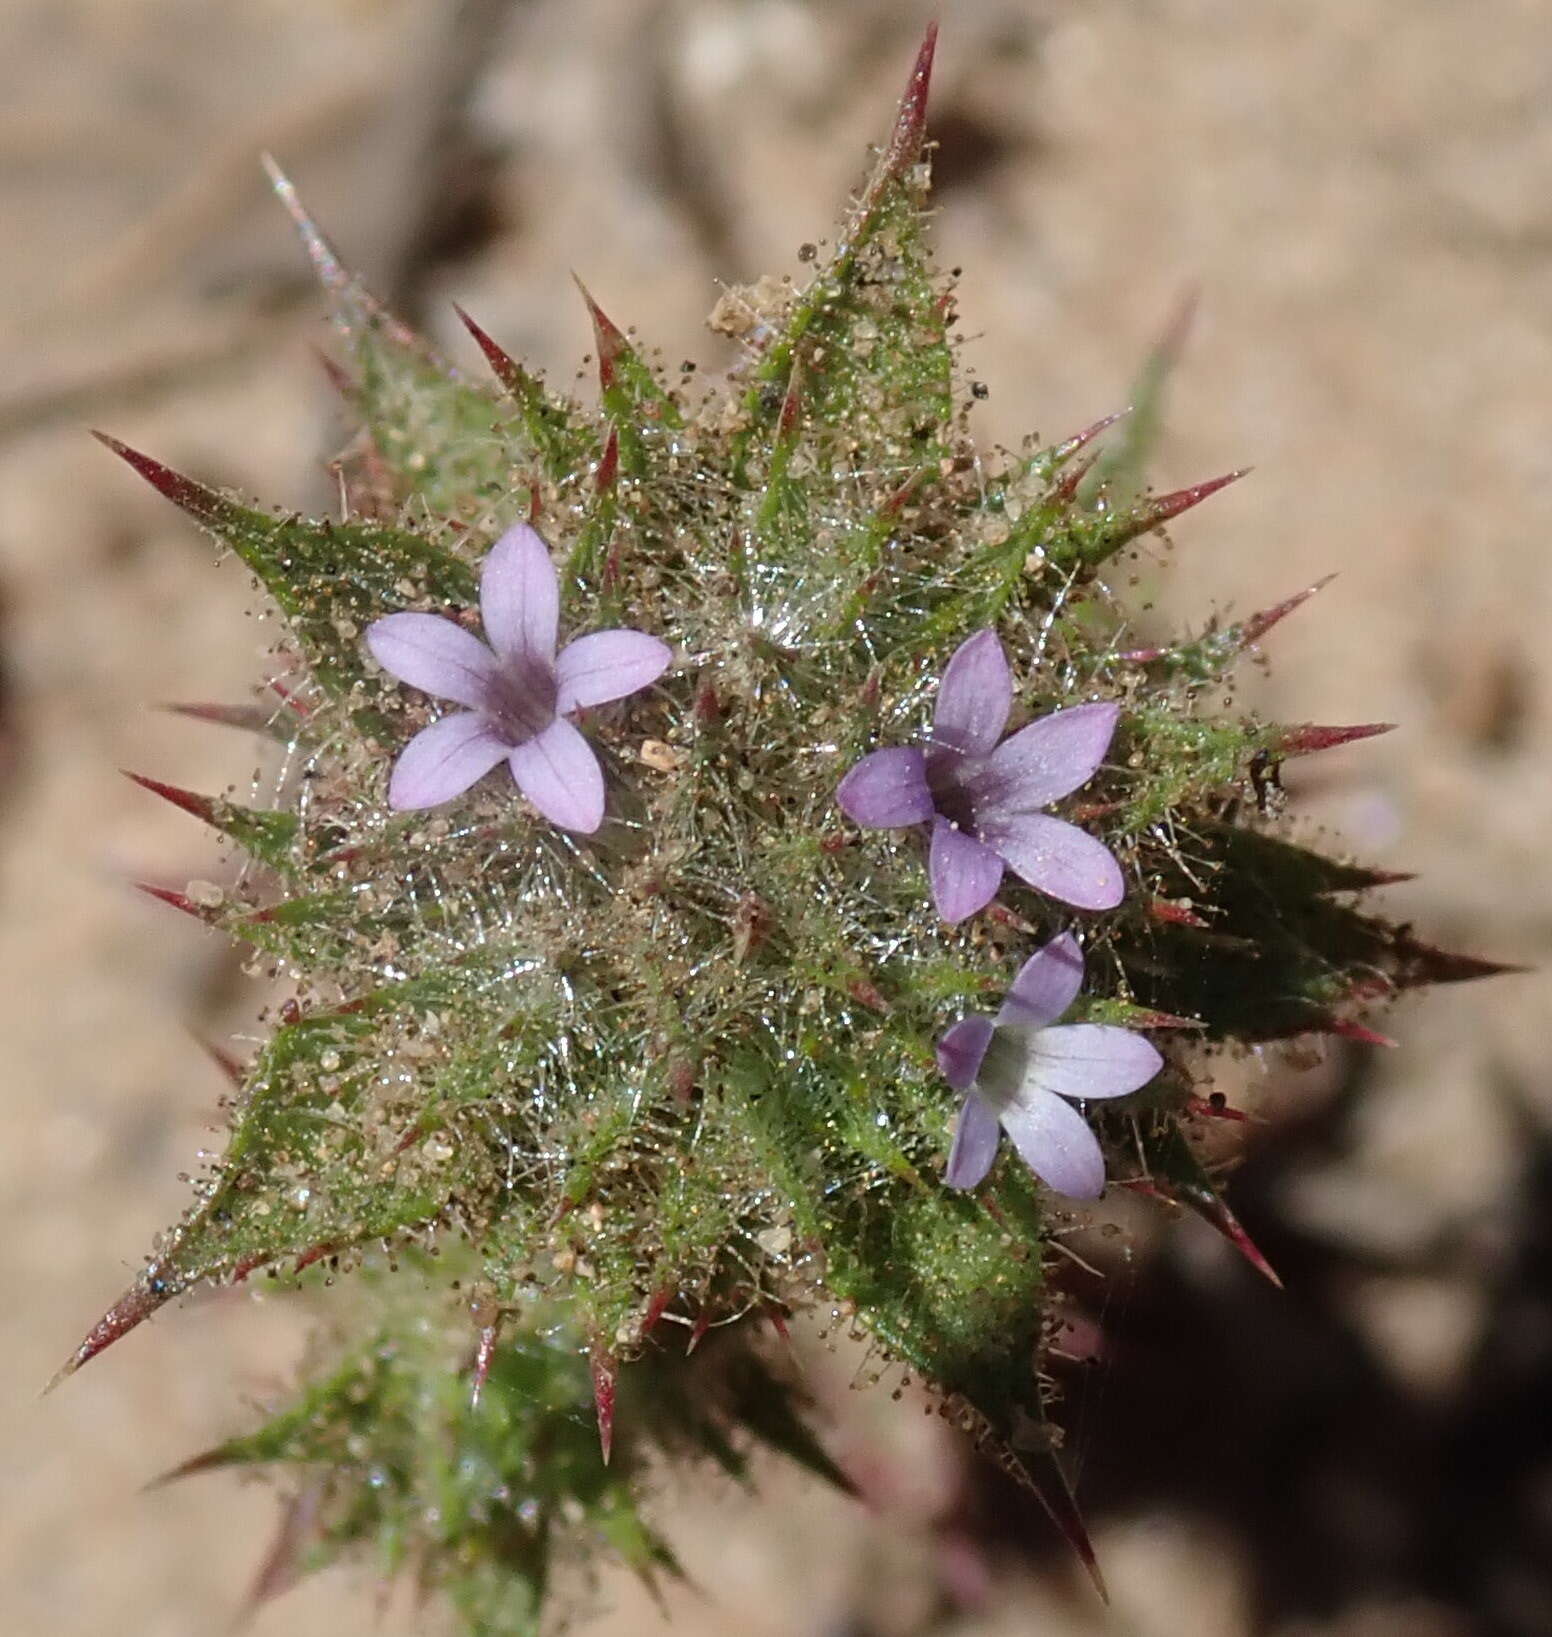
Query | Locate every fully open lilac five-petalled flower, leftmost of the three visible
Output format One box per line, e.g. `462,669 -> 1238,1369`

367,522 -> 673,835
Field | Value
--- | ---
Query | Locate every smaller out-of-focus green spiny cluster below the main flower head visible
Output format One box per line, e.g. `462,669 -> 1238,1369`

153,1254 -> 846,1637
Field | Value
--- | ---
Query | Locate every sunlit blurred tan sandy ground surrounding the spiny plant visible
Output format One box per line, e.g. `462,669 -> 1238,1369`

0,0 -> 1552,1637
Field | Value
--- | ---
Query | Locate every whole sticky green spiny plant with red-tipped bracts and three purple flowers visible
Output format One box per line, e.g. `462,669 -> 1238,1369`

62,22 -> 1498,1634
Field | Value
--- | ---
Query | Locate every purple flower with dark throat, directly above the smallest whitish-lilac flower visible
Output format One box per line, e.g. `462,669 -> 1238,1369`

837,630 -> 1125,922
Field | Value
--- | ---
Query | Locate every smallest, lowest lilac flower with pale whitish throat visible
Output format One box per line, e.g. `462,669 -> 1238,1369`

938,933 -> 1164,1200
